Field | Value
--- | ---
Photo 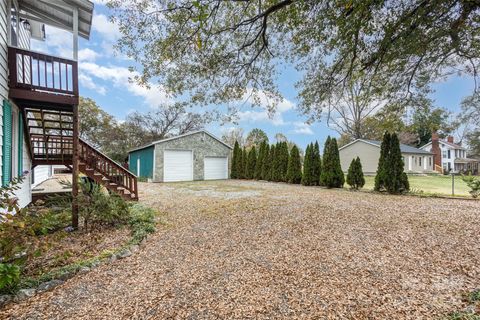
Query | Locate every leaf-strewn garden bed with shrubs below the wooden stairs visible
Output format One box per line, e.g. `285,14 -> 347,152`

0,179 -> 156,294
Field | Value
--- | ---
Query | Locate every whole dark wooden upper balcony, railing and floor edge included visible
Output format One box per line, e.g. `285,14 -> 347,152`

8,47 -> 78,110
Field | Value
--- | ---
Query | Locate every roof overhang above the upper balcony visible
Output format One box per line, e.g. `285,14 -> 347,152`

17,0 -> 94,40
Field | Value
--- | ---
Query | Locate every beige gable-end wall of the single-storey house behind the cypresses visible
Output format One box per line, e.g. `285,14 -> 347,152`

339,141 -> 380,173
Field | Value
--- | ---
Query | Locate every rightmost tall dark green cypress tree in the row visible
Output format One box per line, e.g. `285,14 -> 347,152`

385,133 -> 409,194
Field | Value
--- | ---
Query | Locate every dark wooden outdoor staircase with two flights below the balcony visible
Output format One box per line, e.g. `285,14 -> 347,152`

24,108 -> 138,201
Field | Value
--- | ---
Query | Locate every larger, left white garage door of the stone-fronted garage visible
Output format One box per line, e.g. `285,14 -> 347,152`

163,150 -> 193,182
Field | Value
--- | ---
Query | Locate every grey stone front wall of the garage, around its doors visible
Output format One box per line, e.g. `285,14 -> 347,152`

153,132 -> 231,182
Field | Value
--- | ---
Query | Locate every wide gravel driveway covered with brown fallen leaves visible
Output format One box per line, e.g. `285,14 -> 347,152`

0,180 -> 480,319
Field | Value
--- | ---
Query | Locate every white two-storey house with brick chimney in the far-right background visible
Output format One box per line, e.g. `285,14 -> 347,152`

420,133 -> 479,173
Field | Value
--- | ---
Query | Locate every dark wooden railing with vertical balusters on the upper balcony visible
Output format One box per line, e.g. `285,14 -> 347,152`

8,47 -> 78,96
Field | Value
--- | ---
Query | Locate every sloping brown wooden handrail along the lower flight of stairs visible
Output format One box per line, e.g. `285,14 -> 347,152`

79,139 -> 138,199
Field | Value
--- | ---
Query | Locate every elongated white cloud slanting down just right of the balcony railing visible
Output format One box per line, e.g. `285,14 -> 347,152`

79,62 -> 172,108
